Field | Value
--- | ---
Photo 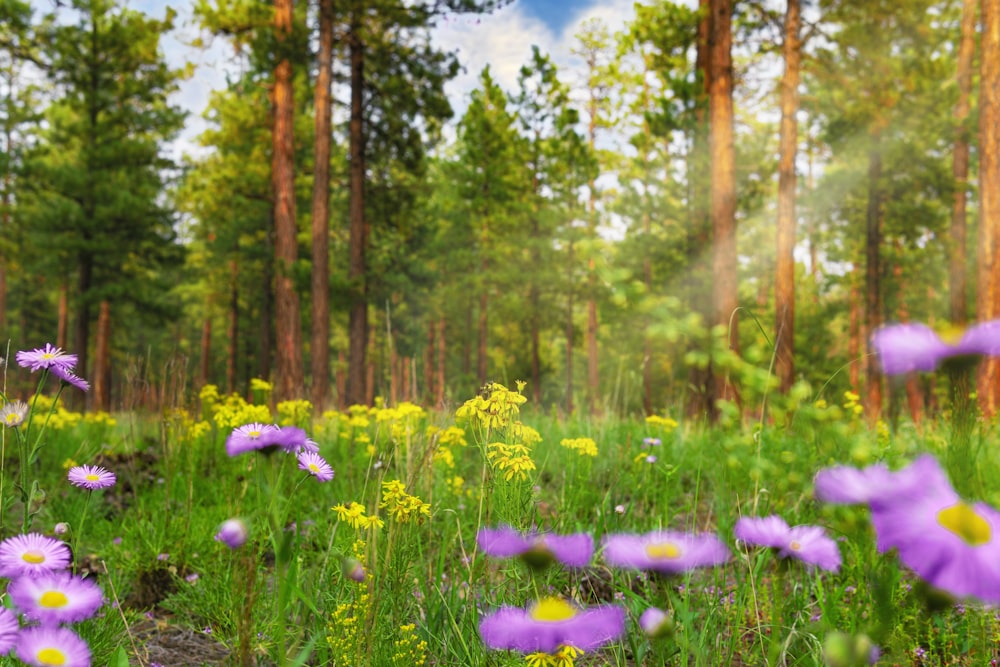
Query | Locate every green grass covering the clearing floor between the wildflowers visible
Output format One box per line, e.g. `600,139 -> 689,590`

2,384 -> 1000,666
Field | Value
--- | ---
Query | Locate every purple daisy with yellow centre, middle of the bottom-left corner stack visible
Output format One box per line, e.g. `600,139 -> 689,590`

7,570 -> 104,625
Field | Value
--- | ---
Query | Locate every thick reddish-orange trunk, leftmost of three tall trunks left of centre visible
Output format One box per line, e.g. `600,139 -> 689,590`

271,0 -> 303,401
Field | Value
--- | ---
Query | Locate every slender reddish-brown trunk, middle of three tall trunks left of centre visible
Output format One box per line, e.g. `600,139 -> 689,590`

309,0 -> 333,414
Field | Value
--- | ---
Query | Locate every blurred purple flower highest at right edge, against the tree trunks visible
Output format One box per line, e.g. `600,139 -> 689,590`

872,320 -> 1000,375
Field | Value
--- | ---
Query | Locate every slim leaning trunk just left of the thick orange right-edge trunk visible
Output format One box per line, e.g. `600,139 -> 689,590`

948,0 -> 976,327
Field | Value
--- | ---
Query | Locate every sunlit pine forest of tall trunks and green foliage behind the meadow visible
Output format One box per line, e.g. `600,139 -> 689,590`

0,0 -> 1000,422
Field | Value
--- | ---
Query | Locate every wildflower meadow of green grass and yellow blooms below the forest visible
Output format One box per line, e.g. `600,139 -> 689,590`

0,352 -> 1000,667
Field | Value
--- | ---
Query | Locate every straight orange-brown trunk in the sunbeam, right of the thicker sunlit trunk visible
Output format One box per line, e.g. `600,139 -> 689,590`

774,0 -> 802,393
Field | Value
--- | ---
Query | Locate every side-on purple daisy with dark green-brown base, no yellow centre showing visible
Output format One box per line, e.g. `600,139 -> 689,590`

476,526 -> 594,568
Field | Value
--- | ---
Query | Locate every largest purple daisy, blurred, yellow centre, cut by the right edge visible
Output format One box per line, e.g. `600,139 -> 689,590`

871,457 -> 1000,604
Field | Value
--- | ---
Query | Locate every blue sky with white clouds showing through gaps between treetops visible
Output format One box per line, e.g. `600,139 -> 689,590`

107,0 -> 635,159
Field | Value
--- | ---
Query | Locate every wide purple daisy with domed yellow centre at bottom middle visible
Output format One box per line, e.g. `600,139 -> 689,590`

479,597 -> 625,653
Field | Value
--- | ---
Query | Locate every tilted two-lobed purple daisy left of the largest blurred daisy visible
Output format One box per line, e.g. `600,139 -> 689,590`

733,515 -> 840,572
